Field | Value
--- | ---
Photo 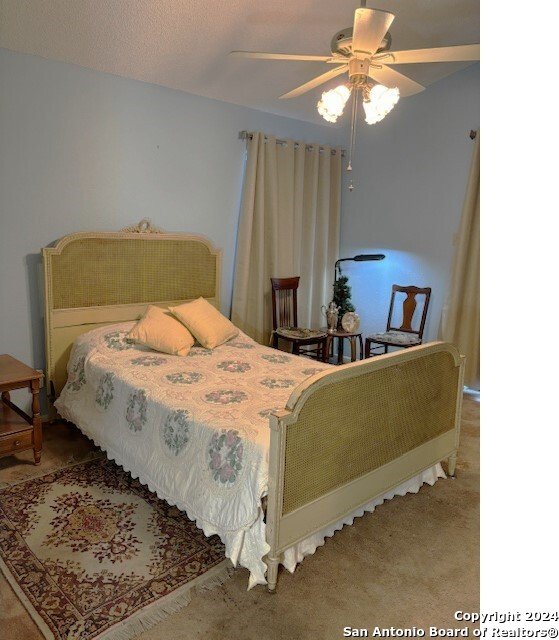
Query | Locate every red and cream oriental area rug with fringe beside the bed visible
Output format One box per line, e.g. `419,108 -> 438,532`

0,458 -> 230,640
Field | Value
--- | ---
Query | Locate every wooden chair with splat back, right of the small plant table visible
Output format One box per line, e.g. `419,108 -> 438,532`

365,284 -> 431,358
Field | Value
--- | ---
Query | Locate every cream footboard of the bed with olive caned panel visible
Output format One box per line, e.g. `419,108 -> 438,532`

266,342 -> 463,590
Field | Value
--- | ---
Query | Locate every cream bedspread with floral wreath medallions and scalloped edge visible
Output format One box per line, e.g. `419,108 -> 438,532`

56,322 -> 330,586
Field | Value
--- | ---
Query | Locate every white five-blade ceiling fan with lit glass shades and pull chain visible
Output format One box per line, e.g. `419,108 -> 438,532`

230,0 -> 480,190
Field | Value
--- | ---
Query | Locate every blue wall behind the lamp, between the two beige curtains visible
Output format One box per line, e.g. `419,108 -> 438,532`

340,65 -> 479,339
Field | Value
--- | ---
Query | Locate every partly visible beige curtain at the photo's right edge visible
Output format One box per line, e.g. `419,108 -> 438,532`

441,131 -> 480,389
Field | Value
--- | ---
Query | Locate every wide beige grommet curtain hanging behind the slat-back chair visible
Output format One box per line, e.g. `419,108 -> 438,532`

231,133 -> 341,344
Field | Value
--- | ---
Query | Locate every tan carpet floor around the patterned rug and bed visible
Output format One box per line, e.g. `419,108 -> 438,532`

0,395 -> 479,640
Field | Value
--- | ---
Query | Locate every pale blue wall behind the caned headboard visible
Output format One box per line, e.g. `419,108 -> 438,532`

0,49 -> 343,404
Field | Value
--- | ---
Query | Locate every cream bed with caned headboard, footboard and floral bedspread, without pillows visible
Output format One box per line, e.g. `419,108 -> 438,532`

43,221 -> 463,590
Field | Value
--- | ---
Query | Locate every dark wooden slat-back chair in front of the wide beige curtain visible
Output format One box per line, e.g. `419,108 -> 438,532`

270,276 -> 327,360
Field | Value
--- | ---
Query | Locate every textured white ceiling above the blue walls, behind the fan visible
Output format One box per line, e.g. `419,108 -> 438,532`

0,0 -> 479,122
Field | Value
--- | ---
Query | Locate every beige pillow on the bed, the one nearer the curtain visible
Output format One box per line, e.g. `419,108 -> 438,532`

169,298 -> 239,349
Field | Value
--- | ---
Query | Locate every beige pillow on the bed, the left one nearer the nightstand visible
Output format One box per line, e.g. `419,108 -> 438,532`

127,305 -> 194,356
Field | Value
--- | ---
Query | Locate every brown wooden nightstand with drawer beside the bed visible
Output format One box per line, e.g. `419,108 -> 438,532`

0,355 -> 43,464
